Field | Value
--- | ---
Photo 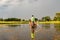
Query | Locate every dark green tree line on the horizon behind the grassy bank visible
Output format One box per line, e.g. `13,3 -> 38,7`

0,13 -> 60,22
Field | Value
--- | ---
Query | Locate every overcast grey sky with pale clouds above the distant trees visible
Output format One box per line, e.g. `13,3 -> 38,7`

0,0 -> 60,19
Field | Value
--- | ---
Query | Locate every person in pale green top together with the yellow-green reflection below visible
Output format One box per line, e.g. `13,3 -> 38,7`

29,15 -> 37,39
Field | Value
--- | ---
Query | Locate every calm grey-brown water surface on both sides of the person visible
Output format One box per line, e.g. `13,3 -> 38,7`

0,24 -> 60,40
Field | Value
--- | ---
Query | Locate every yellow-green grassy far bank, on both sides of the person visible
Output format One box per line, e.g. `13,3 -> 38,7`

0,21 -> 60,24
